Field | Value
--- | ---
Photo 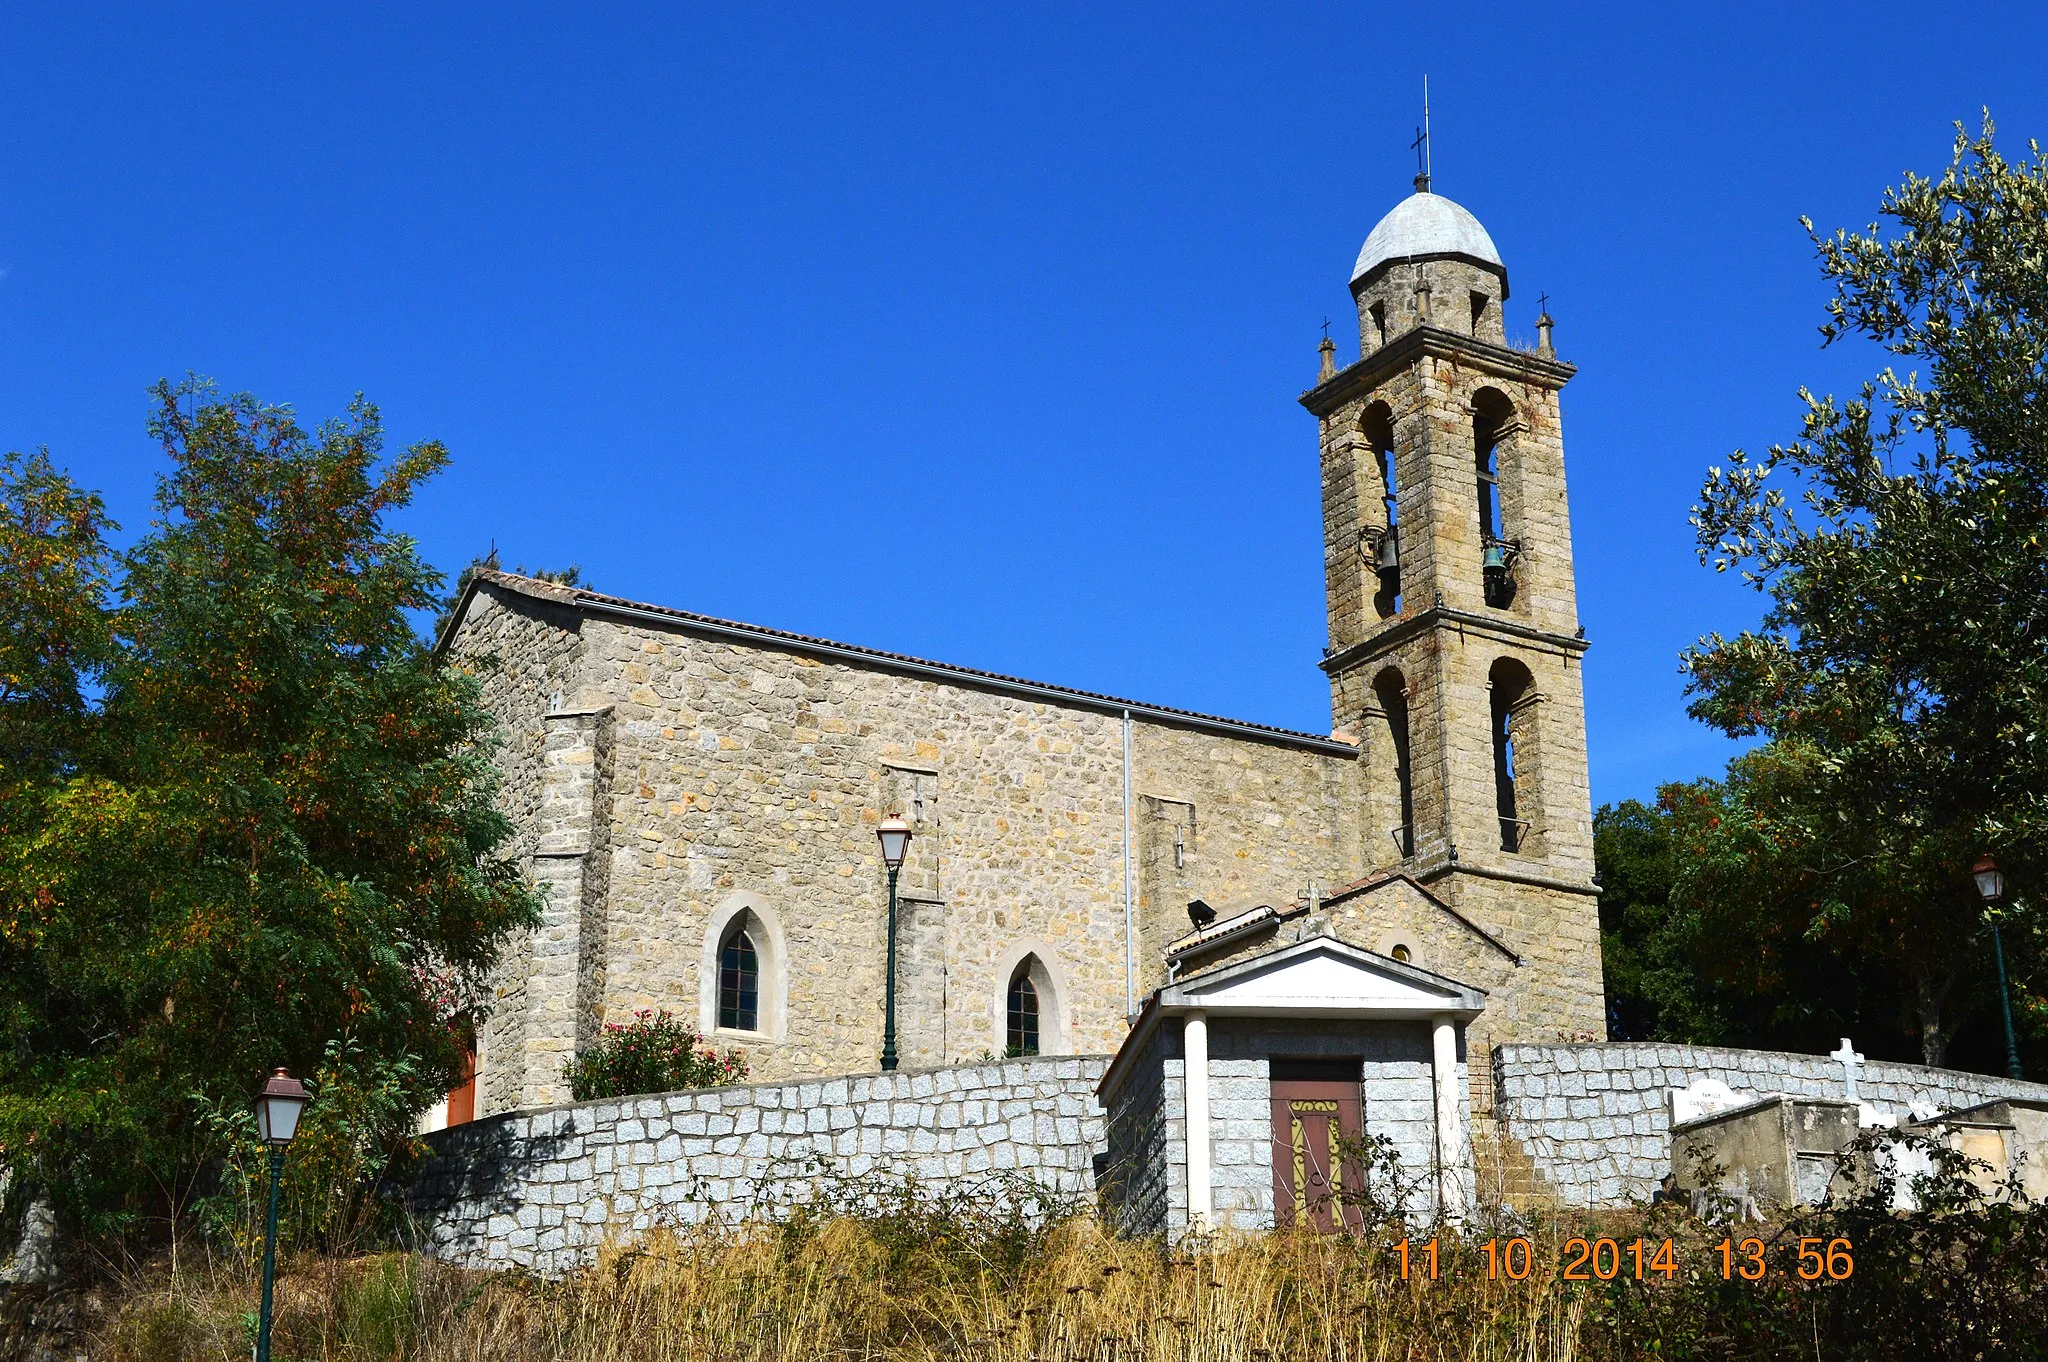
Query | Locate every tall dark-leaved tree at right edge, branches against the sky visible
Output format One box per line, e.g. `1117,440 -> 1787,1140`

1679,115 -> 2048,1063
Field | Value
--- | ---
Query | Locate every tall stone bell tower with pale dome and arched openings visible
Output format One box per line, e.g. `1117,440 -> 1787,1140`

1300,176 -> 1602,1030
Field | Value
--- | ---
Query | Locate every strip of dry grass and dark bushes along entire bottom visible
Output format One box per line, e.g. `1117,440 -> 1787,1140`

64,1133 -> 2048,1362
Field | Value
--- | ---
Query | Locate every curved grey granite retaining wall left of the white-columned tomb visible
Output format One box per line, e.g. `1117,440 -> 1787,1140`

412,1055 -> 1108,1274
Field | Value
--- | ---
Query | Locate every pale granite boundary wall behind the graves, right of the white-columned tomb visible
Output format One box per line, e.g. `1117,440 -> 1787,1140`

1493,1042 -> 2048,1206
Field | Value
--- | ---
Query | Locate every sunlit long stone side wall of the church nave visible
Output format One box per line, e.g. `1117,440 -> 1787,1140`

464,592 -> 1364,1110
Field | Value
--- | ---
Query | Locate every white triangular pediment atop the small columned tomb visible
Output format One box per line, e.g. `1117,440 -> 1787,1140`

1161,936 -> 1485,1016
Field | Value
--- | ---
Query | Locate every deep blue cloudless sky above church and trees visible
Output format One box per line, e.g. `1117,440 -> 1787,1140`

0,2 -> 2048,801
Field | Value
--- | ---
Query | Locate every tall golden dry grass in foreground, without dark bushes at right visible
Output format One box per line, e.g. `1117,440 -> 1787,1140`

92,1217 -> 1613,1362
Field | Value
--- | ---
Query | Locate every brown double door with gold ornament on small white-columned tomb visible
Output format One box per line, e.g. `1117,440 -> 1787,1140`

1272,1059 -> 1364,1233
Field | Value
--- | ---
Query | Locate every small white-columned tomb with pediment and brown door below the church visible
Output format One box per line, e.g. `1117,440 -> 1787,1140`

1098,936 -> 1485,1235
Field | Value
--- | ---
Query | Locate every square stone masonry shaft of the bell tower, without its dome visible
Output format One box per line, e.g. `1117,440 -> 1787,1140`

1305,321 -> 1606,1110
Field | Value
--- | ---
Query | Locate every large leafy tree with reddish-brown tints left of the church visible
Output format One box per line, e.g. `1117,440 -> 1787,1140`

0,379 -> 535,1231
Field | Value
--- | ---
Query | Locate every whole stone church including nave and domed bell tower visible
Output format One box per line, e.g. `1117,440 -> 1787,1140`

438,180 -> 1604,1157
